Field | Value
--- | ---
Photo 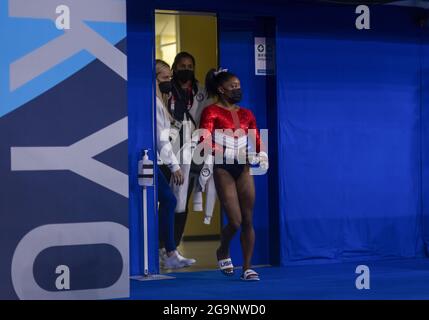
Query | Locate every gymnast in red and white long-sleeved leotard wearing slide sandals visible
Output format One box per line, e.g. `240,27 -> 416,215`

200,70 -> 268,281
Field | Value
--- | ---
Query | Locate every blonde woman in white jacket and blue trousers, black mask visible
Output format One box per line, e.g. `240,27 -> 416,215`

156,60 -> 188,269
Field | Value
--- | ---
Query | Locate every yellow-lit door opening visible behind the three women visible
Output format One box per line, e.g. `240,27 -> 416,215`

155,10 -> 221,272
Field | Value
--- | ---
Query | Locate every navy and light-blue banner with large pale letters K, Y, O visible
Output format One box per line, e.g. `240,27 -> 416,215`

0,1 -> 129,300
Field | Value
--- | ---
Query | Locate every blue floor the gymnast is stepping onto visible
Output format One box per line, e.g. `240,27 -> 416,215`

131,259 -> 429,300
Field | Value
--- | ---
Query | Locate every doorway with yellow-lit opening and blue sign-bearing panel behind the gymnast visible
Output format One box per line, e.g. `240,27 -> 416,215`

155,10 -> 280,272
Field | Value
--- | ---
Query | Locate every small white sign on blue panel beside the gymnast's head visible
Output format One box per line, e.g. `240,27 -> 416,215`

255,37 -> 275,76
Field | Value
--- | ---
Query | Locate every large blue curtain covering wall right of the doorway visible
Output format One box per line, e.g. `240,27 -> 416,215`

277,7 -> 424,264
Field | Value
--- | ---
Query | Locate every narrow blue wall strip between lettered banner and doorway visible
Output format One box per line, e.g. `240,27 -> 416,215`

127,1 -> 158,275
